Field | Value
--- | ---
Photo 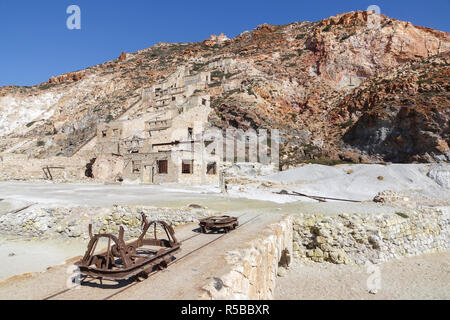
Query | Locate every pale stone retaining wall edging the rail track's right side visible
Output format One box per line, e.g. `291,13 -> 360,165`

201,217 -> 293,300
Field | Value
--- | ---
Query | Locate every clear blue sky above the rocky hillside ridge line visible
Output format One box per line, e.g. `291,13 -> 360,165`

0,0 -> 450,86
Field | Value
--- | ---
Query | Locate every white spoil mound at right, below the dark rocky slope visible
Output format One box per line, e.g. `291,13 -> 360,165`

230,164 -> 450,205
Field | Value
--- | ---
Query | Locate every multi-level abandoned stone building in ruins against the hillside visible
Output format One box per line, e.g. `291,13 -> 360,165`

93,69 -> 221,184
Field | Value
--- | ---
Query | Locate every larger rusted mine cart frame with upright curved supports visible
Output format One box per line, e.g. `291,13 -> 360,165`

75,213 -> 180,280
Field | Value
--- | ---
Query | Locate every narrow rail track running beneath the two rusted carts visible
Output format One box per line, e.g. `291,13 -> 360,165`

42,213 -> 258,300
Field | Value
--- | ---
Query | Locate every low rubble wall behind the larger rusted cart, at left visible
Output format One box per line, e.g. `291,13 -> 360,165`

0,206 -> 214,239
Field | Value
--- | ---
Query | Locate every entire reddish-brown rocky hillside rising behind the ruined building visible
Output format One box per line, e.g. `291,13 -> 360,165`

0,12 -> 450,167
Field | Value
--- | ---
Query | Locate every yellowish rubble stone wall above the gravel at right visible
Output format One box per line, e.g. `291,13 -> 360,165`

293,208 -> 450,265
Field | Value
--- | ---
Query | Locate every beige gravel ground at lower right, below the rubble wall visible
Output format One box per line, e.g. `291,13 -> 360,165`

275,252 -> 450,300
